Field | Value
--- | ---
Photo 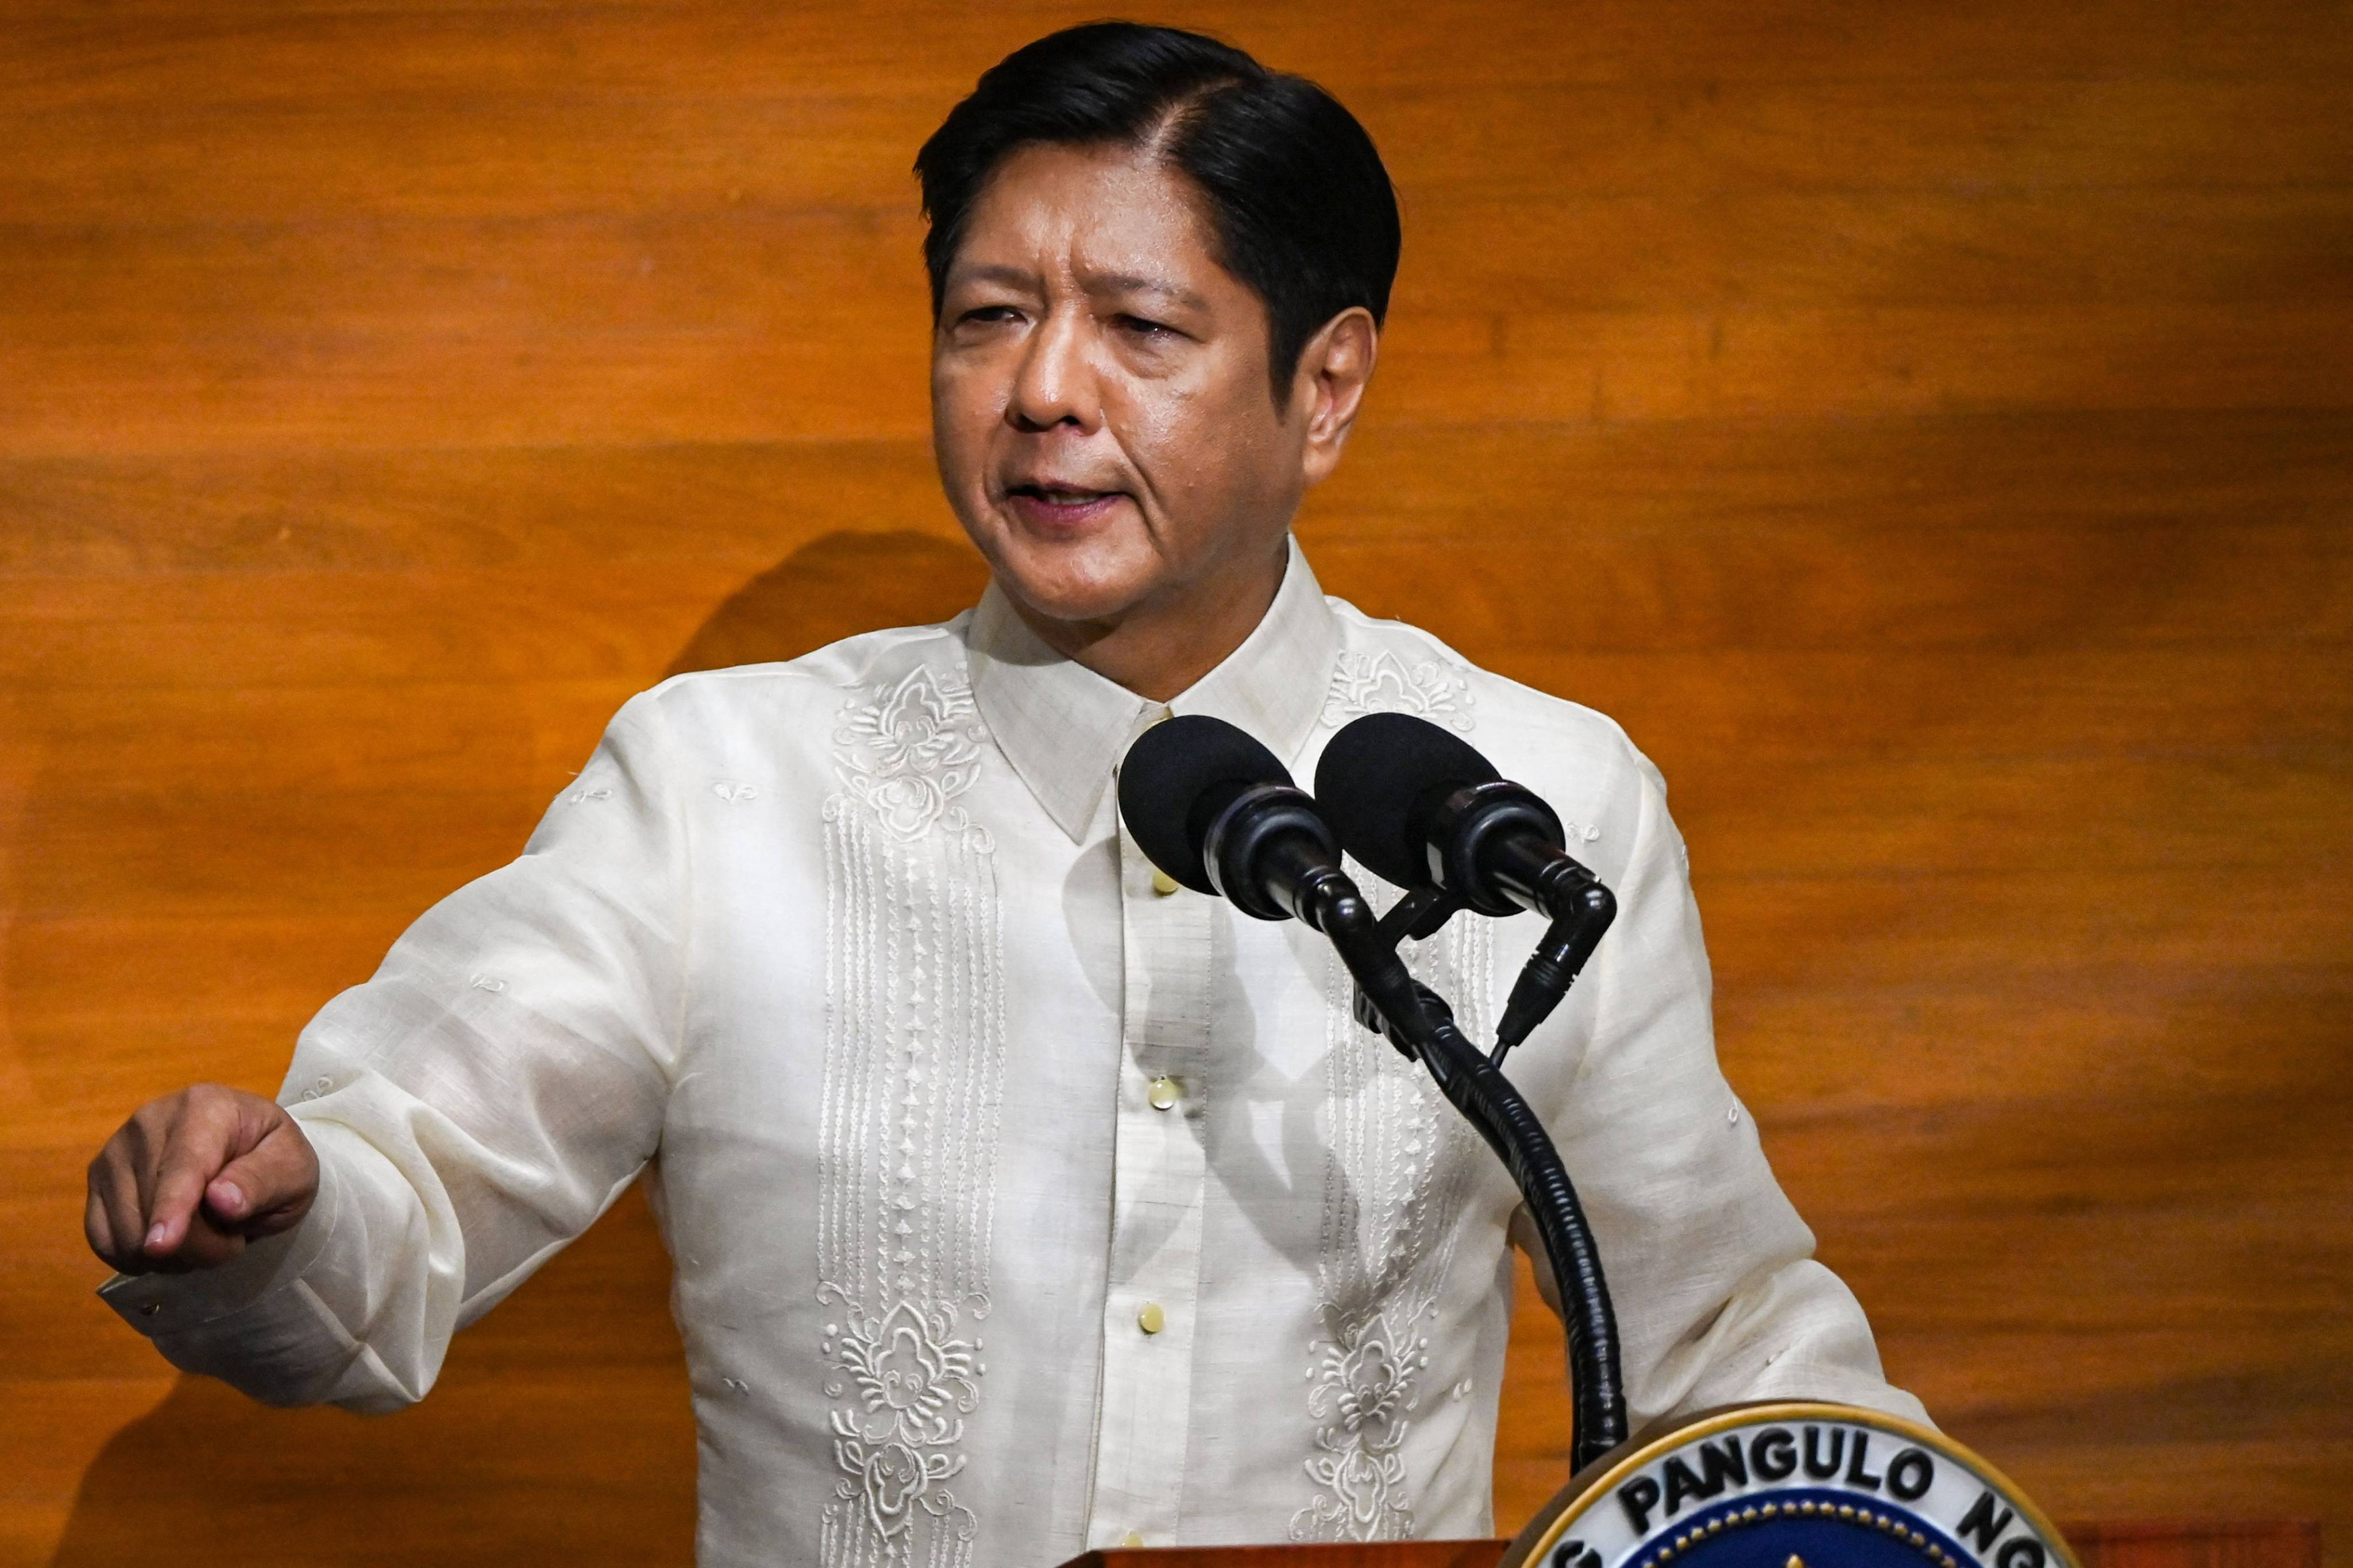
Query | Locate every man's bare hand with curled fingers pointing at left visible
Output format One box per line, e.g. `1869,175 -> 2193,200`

82,1084 -> 318,1274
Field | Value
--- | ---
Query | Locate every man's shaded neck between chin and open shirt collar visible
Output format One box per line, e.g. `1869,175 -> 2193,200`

1005,538 -> 1290,703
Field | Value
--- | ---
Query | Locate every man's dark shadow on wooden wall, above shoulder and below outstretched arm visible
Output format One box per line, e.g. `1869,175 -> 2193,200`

52,531 -> 988,1568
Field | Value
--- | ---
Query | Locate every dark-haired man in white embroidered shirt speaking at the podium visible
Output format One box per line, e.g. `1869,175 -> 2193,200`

87,24 -> 1918,1563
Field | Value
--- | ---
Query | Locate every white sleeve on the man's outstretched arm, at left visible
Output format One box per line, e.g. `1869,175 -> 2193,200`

101,693 -> 687,1411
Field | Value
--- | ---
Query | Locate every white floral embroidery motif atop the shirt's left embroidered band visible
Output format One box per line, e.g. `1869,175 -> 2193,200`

833,665 -> 988,839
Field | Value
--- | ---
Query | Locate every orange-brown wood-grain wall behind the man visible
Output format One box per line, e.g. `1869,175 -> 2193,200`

0,0 -> 2353,1563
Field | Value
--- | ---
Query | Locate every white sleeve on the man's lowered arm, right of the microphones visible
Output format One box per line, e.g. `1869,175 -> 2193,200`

1541,748 -> 1925,1432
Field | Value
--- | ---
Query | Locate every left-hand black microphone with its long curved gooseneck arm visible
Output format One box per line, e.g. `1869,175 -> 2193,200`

1120,715 -> 1626,1469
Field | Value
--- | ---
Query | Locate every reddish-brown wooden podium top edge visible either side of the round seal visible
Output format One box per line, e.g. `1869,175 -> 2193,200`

1066,1519 -> 2320,1568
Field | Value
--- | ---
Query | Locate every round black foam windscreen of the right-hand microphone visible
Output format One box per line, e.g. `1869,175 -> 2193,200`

1316,712 -> 1501,886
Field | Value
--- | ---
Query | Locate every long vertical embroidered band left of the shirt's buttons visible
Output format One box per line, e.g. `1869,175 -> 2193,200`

816,665 -> 1005,1568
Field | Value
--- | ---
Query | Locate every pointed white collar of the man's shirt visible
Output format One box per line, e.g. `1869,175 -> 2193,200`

967,538 -> 1339,844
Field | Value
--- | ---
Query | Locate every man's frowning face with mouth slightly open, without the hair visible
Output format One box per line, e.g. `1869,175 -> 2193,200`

932,146 -> 1316,625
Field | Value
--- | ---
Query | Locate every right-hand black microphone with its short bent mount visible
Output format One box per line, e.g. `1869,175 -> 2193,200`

1316,712 -> 1617,1060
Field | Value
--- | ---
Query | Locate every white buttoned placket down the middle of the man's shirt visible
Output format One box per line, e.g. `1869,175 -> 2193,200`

1087,799 -> 1219,1547
